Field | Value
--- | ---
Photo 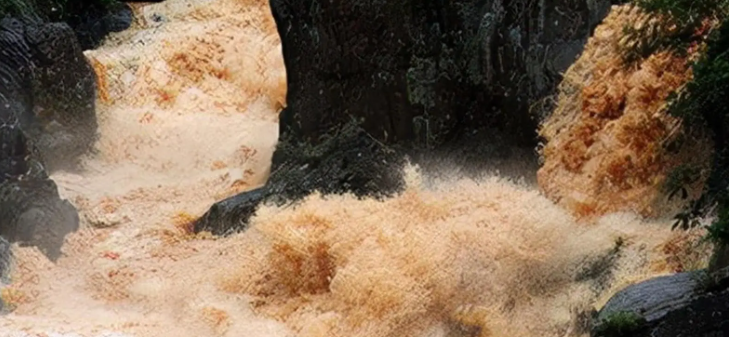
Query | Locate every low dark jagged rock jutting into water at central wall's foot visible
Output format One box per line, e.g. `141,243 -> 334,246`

195,123 -> 404,235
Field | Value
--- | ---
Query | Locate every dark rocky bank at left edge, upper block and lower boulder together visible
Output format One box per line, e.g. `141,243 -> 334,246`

0,18 -> 91,260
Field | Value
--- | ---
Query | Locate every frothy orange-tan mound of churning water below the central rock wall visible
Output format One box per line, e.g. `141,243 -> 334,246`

221,165 -> 704,336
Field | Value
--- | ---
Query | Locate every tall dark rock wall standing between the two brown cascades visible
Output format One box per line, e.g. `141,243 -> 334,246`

196,0 -> 611,233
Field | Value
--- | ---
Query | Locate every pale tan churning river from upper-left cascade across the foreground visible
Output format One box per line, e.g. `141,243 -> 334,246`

0,0 -> 702,337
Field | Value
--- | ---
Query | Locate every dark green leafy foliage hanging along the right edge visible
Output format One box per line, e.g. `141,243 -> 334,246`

628,0 -> 729,256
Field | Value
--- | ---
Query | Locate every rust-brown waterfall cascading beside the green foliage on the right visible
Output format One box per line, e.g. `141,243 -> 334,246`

537,5 -> 709,218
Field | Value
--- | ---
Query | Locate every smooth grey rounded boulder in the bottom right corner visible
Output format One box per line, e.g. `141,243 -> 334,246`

591,268 -> 729,337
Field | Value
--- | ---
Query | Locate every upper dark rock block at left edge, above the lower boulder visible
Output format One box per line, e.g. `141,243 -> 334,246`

0,18 -> 97,172
